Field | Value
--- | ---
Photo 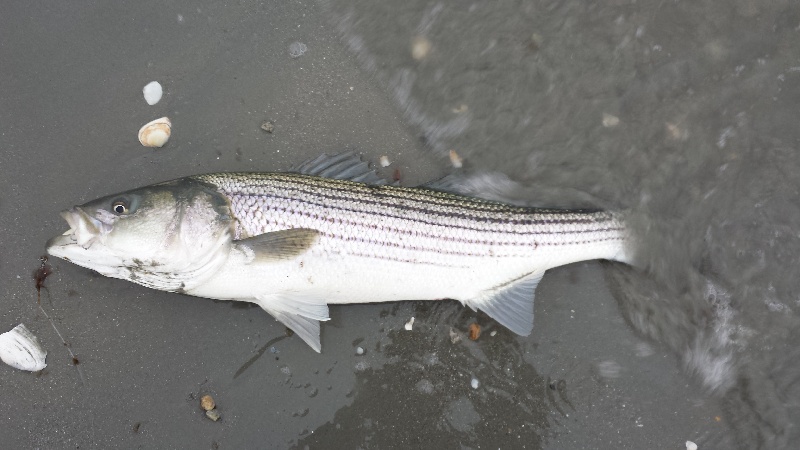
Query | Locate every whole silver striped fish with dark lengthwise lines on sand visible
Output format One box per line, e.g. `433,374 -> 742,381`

47,153 -> 634,352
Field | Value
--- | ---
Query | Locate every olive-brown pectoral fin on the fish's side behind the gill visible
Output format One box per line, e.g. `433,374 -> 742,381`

235,228 -> 319,261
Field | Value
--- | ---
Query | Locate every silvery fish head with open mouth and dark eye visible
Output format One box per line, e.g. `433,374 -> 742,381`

47,177 -> 233,291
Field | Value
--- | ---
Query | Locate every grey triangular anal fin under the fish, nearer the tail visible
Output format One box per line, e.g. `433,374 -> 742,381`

466,272 -> 544,336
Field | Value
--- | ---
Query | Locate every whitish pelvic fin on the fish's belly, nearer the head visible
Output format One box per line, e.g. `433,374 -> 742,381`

256,294 -> 330,353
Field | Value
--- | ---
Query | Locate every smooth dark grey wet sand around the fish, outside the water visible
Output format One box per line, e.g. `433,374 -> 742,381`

0,2 -> 768,449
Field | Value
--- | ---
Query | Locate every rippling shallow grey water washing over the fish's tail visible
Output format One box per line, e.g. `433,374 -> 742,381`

324,1 -> 800,448
